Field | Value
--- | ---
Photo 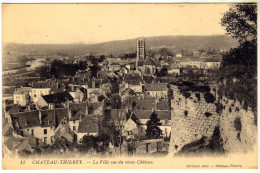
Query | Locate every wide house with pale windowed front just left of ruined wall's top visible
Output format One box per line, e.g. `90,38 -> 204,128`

144,83 -> 168,98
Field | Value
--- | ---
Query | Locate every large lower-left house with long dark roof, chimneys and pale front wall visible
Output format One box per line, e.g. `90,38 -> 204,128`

11,108 -> 68,146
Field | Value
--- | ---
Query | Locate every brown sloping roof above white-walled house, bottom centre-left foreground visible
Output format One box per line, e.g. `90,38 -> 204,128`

78,116 -> 99,133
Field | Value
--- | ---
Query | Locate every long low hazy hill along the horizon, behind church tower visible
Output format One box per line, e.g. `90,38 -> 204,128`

3,35 -> 238,58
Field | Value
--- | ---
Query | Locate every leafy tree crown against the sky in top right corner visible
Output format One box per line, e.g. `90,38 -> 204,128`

221,3 -> 257,43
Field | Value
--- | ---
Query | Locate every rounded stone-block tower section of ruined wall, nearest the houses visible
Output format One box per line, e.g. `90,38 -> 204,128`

170,86 -> 220,153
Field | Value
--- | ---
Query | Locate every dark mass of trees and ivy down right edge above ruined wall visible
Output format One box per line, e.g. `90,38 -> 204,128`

218,3 -> 257,122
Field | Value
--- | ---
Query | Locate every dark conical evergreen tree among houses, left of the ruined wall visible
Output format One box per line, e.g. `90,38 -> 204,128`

145,112 -> 162,139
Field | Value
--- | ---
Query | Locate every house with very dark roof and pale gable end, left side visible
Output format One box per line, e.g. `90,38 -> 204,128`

36,91 -> 73,108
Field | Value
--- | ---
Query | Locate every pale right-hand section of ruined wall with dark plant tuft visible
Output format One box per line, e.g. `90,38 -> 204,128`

220,98 -> 257,154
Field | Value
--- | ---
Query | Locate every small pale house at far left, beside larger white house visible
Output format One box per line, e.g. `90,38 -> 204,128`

13,87 -> 32,106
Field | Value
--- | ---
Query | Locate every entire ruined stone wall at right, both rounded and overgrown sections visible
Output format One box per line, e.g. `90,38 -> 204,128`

169,85 -> 257,154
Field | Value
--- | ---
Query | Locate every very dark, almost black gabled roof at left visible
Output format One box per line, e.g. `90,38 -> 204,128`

42,91 -> 73,103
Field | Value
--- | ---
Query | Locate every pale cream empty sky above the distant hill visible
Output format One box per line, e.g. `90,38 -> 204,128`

2,4 -> 229,44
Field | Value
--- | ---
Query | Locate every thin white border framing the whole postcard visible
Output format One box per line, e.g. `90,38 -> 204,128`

0,0 -> 260,173
